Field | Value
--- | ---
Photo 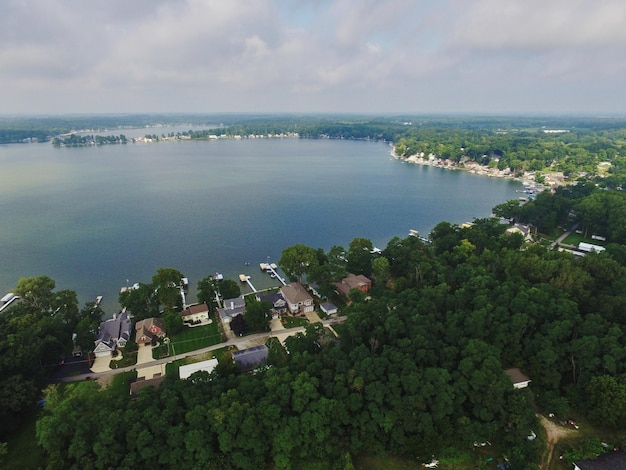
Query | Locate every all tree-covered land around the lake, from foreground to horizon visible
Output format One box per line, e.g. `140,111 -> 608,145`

0,115 -> 626,470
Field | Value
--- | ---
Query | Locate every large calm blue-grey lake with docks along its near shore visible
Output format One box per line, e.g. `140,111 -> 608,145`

0,135 -> 521,313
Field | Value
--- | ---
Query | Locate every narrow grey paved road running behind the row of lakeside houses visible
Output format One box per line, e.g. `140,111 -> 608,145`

51,317 -> 347,383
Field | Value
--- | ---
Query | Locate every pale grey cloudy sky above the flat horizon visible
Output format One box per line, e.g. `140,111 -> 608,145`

0,0 -> 626,115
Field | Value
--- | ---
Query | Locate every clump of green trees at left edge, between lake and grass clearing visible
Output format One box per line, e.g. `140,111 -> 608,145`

0,276 -> 103,442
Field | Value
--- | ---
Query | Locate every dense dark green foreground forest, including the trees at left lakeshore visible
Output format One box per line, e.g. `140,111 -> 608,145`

0,184 -> 626,469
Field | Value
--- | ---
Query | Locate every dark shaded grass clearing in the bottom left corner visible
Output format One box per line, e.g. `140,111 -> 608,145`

0,411 -> 45,470
